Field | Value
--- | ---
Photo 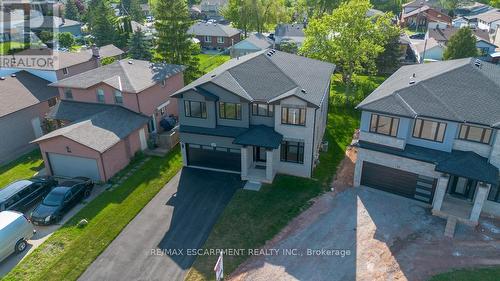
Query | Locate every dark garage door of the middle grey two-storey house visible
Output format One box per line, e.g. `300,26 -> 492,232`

186,144 -> 241,172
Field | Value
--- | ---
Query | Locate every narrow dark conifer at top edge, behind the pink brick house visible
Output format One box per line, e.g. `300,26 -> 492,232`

89,0 -> 118,47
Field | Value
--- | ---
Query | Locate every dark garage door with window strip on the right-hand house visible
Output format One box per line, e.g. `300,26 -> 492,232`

361,161 -> 436,203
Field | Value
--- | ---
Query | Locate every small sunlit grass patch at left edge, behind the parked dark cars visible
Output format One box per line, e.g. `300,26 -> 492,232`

0,149 -> 43,189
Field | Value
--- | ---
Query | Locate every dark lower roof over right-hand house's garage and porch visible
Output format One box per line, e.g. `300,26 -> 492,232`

357,141 -> 498,185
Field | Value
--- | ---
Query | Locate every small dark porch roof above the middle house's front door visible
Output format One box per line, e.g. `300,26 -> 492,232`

233,125 -> 283,149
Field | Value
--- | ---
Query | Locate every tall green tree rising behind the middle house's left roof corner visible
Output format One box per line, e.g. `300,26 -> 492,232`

155,0 -> 199,82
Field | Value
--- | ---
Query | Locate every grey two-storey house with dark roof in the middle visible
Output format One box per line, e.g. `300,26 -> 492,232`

173,50 -> 335,182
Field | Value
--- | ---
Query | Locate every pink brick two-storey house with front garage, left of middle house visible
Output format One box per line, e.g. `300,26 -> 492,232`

34,59 -> 188,181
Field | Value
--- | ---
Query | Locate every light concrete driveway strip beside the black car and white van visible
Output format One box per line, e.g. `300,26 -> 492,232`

0,185 -> 105,277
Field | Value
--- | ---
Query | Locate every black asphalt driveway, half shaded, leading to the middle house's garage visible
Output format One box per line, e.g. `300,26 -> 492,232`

79,168 -> 243,281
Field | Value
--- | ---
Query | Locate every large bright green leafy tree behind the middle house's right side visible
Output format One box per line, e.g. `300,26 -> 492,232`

299,0 -> 396,87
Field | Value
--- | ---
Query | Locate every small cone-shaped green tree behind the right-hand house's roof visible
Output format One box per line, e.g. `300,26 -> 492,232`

443,27 -> 478,60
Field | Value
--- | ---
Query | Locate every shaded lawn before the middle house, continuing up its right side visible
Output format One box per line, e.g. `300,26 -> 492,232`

186,74 -> 378,281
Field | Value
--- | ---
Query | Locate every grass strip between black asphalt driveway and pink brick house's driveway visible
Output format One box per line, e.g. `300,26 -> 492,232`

4,147 -> 182,281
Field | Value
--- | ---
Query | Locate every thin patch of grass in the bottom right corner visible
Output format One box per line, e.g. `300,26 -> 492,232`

430,267 -> 500,281
